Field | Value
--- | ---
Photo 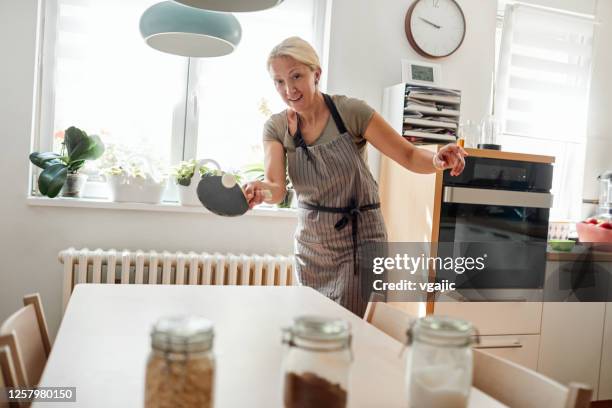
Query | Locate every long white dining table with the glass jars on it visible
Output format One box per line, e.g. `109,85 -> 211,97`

33,284 -> 503,408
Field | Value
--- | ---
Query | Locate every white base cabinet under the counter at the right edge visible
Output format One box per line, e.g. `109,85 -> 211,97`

538,252 -> 612,400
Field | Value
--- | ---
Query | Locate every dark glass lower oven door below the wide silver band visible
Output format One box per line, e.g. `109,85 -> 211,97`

436,203 -> 549,289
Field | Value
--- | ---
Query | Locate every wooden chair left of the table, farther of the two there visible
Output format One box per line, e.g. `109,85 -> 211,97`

0,293 -> 51,387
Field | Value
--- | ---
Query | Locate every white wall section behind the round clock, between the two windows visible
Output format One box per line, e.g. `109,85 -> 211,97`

328,0 -> 497,178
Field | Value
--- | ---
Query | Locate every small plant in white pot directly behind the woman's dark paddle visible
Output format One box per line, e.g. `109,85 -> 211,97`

172,159 -> 222,206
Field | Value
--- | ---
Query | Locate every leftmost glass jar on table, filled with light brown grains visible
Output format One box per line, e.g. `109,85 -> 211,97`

145,316 -> 215,408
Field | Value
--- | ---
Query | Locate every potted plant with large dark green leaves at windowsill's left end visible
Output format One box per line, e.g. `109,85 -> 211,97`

30,126 -> 104,198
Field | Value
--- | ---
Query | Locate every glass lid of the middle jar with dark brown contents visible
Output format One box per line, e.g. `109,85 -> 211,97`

286,316 -> 351,344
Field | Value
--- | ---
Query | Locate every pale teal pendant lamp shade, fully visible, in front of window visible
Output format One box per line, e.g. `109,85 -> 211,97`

140,1 -> 242,57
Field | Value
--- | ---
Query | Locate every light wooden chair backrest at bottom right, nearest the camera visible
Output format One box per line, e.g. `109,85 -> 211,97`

473,350 -> 593,408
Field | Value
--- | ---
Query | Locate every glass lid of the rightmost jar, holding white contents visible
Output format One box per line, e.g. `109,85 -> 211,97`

408,316 -> 476,346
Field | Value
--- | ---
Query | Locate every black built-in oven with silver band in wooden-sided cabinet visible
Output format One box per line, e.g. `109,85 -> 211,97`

436,157 -> 553,301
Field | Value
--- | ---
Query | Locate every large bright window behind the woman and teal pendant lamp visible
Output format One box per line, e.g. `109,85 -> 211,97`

33,0 -> 326,196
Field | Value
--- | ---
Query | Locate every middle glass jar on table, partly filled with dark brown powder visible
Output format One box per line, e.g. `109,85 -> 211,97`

283,316 -> 352,408
